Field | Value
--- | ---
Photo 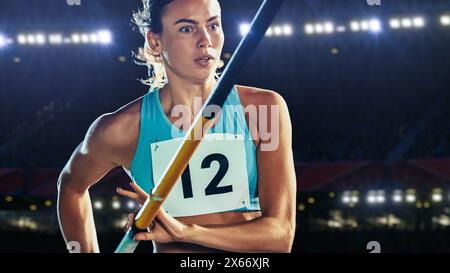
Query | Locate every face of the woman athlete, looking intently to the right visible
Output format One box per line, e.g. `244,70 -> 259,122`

150,0 -> 224,83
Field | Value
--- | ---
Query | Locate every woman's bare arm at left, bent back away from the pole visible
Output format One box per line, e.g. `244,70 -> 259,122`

58,115 -> 124,252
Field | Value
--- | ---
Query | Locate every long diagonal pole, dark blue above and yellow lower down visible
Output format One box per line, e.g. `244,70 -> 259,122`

116,0 -> 284,253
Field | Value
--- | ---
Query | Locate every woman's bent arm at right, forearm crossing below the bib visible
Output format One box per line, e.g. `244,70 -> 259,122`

183,90 -> 296,252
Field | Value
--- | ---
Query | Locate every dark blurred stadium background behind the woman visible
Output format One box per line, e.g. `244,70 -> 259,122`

0,0 -> 450,253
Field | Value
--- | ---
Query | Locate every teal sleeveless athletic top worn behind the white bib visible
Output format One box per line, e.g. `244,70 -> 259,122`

128,87 -> 260,214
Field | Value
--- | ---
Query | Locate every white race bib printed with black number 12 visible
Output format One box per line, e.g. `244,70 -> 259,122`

151,134 -> 250,217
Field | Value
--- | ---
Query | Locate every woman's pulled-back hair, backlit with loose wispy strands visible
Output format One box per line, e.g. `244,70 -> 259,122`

131,0 -> 224,89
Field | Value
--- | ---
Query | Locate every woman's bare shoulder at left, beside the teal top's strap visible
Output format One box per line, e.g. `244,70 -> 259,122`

83,97 -> 142,164
